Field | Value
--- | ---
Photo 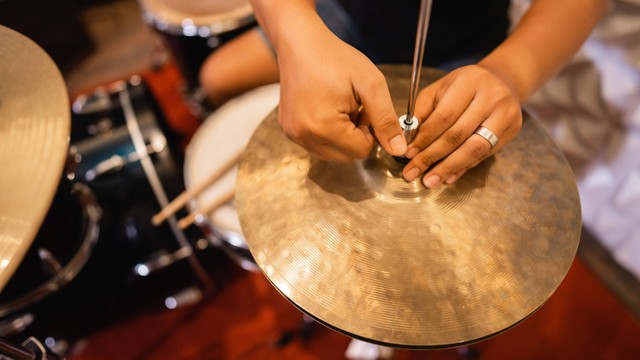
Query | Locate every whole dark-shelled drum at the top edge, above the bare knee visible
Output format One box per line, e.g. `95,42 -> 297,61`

138,0 -> 255,115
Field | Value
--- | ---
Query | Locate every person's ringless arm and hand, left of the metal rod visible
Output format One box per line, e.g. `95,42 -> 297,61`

251,0 -> 407,161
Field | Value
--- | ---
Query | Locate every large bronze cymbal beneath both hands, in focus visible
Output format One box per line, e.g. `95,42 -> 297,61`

236,66 -> 581,349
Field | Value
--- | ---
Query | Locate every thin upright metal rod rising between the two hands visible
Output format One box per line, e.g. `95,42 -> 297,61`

398,0 -> 433,143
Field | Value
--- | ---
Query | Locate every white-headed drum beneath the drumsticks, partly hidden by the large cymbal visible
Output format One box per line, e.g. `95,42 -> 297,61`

184,84 -> 280,271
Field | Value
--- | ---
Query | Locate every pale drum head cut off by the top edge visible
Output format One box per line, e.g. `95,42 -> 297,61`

138,0 -> 253,29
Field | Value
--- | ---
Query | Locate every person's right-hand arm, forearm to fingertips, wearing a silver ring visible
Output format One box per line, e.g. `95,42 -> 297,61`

403,0 -> 609,188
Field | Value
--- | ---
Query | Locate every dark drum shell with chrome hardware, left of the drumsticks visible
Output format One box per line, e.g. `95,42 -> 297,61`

71,76 -> 200,278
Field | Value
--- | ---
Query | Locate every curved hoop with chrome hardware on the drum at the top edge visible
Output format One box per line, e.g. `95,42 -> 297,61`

141,0 -> 255,37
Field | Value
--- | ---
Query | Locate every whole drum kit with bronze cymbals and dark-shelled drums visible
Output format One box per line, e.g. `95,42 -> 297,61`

0,0 -> 581,349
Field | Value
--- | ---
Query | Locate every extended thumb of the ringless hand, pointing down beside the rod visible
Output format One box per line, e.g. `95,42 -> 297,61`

354,73 -> 407,156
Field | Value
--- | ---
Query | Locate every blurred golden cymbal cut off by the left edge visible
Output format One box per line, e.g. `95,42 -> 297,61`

0,25 -> 71,290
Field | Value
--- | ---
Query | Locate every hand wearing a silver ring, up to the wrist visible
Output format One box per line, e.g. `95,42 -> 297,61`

403,65 -> 522,188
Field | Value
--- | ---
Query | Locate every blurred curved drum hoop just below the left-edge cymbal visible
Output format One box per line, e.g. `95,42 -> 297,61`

0,183 -> 102,317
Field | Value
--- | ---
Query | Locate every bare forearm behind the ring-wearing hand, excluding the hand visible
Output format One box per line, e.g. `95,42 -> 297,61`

480,0 -> 609,101
